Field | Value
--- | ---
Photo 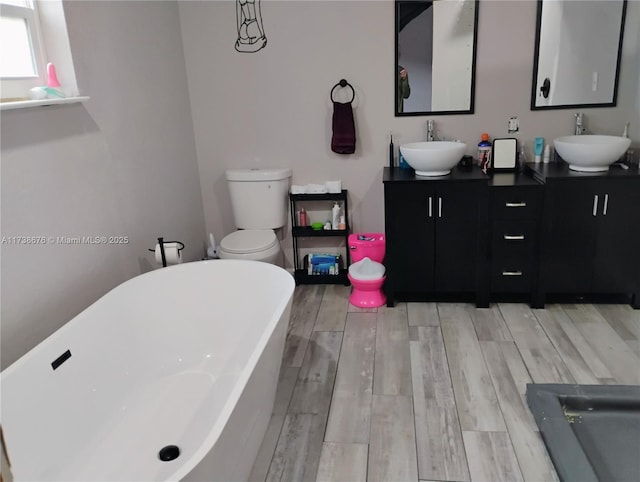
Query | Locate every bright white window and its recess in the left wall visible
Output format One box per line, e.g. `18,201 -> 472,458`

0,0 -> 78,103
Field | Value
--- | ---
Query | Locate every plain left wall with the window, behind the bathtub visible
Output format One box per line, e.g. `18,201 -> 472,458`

1,1 -> 205,367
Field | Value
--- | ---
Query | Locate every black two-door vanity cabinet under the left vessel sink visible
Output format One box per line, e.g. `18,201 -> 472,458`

383,168 -> 488,306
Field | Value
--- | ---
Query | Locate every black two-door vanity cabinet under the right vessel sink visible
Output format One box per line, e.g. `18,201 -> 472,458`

537,165 -> 640,308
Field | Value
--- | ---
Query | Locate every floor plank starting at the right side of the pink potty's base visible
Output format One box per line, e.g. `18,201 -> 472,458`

373,303 -> 411,395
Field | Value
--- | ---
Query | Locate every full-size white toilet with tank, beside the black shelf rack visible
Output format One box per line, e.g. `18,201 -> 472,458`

218,168 -> 291,265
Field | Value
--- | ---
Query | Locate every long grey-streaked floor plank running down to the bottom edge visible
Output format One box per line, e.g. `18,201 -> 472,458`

410,327 -> 470,481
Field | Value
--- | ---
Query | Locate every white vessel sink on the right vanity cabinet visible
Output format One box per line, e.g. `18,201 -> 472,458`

553,135 -> 631,172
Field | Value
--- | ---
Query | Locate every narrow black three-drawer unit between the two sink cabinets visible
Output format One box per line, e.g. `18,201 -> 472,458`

489,173 -> 544,306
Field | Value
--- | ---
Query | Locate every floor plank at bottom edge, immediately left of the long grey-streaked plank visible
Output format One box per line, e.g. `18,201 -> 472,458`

367,395 -> 418,482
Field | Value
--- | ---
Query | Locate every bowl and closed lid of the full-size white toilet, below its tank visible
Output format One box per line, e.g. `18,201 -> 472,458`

218,229 -> 282,265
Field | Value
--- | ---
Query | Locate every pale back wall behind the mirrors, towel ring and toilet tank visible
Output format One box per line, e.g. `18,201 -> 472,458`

180,0 -> 640,272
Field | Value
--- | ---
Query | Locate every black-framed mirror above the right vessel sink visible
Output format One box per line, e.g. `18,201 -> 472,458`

531,0 -> 627,110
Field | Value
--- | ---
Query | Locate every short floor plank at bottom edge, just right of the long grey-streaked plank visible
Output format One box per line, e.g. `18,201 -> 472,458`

462,432 -> 523,482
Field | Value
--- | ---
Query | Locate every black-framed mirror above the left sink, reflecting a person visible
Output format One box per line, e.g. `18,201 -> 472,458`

394,0 -> 478,117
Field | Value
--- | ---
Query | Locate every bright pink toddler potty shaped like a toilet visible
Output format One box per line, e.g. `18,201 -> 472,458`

347,233 -> 387,308
